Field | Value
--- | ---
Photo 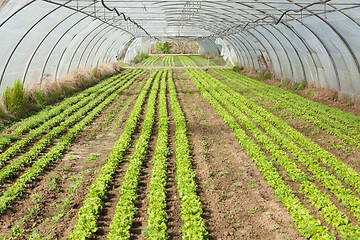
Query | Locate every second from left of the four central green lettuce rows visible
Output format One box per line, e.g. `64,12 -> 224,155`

107,71 -> 162,240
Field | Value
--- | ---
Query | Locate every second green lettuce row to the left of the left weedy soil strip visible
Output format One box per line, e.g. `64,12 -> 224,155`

0,71 -> 144,184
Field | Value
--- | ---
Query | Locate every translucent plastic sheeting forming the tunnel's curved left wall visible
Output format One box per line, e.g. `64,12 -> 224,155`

0,1 -> 132,92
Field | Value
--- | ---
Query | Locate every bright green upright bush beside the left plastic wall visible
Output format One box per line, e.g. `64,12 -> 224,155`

4,79 -> 26,118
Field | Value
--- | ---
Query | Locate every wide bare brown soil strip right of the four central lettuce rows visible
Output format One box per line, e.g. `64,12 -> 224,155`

175,70 -> 302,239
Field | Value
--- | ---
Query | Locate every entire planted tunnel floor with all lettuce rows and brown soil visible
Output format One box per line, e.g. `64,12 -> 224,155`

0,56 -> 360,239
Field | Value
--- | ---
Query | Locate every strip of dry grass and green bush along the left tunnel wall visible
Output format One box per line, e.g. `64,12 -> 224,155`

0,63 -> 122,128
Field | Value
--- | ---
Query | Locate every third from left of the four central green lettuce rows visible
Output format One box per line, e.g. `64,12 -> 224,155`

147,68 -> 170,240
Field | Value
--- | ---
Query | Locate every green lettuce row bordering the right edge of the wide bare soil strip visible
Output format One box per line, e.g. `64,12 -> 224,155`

187,70 -> 333,239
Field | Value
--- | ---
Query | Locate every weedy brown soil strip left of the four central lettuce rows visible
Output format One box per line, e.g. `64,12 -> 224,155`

0,74 -> 147,239
